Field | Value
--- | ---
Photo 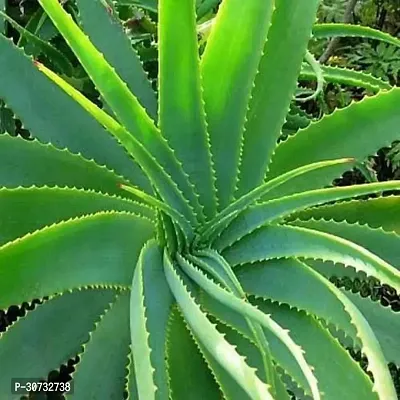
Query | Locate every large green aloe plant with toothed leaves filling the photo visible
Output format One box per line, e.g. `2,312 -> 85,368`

0,0 -> 400,400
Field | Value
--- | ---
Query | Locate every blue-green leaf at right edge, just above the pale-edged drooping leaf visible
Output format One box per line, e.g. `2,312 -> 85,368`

292,220 -> 400,270
